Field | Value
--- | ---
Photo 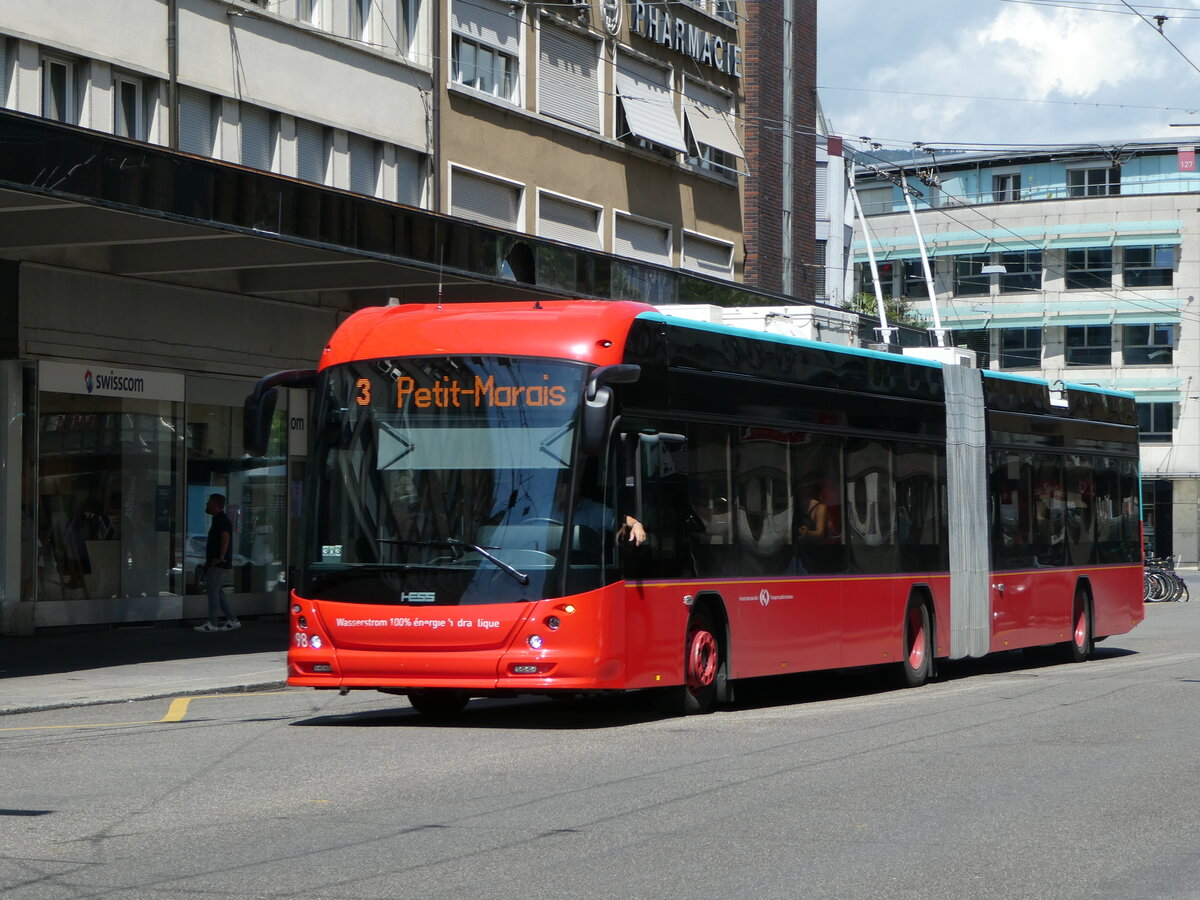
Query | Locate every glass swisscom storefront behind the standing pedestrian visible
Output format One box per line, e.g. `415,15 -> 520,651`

19,361 -> 294,628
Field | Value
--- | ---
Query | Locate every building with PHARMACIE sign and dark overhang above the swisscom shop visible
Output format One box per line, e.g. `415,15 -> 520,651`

0,0 -> 815,634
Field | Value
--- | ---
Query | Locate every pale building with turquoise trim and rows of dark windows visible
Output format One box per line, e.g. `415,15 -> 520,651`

847,139 -> 1200,564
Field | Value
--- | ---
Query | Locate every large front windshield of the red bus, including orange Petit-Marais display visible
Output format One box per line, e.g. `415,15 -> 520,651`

301,356 -> 587,605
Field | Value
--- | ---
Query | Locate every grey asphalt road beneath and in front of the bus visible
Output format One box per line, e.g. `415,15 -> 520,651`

0,595 -> 1200,900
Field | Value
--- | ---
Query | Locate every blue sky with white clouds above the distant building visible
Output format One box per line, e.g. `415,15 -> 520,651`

817,0 -> 1200,149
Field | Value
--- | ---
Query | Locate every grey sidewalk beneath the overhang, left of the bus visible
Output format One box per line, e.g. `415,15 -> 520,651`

0,617 -> 288,715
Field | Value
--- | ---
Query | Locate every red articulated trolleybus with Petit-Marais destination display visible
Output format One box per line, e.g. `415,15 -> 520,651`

246,300 -> 1144,713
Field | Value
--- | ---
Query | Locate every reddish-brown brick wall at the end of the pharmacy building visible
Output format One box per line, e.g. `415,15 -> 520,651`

743,0 -> 824,300
